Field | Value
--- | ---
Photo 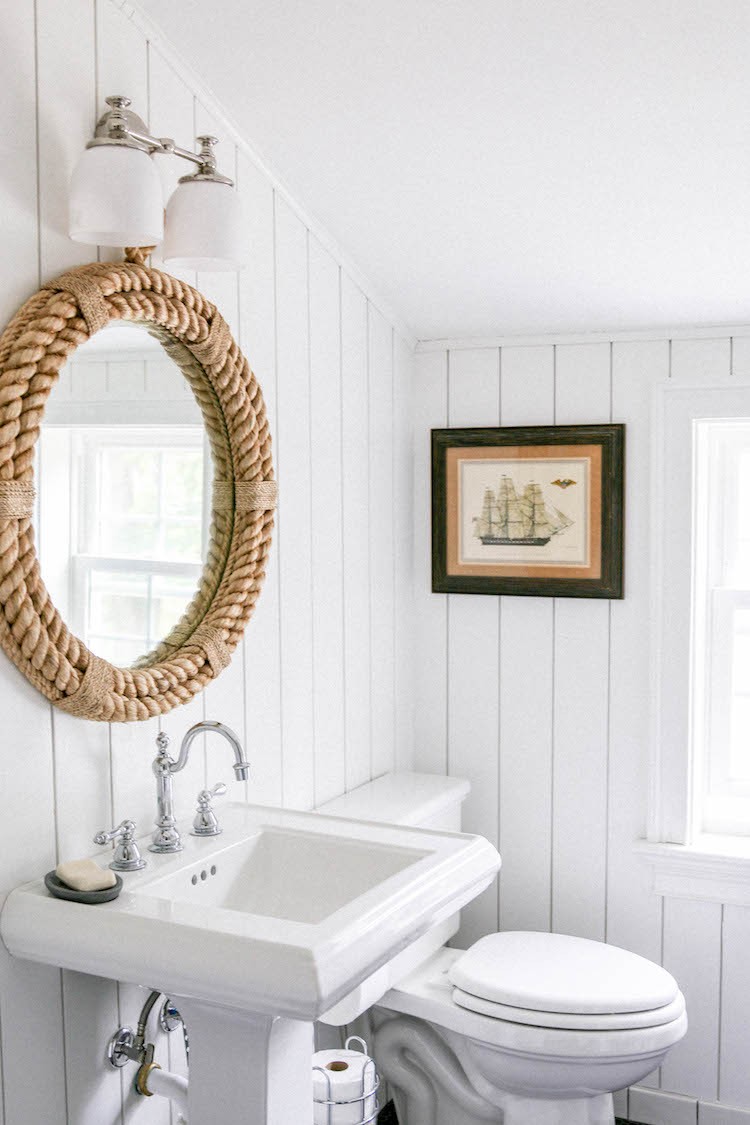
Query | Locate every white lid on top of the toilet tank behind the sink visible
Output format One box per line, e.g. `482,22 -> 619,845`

316,772 -> 471,826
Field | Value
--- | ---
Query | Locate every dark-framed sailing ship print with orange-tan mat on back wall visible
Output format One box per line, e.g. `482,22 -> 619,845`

432,425 -> 625,597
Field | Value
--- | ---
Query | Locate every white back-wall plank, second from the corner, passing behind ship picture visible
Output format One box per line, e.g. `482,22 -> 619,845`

448,348 -> 500,947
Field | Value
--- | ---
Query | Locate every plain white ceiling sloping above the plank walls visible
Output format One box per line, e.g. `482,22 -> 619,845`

139,0 -> 750,339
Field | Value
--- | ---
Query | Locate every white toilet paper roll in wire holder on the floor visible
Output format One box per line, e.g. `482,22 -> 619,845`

313,1050 -> 377,1125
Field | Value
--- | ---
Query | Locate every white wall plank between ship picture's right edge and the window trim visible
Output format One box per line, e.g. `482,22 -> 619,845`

606,341 -> 669,961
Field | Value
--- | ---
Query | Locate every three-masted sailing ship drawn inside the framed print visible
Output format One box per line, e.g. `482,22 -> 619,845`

473,475 -> 573,547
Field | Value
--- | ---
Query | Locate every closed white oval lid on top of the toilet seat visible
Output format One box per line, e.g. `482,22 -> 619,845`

449,930 -> 679,1016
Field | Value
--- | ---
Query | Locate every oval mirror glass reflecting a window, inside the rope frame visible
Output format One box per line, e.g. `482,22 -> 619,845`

35,322 -> 211,667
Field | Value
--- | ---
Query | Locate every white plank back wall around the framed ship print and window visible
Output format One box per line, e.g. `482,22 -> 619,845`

414,329 -> 750,1125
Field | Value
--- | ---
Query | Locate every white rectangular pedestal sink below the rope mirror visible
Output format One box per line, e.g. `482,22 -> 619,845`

0,803 -> 500,1125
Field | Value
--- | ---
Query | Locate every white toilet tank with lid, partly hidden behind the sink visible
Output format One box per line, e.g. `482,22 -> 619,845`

315,772 -> 470,1027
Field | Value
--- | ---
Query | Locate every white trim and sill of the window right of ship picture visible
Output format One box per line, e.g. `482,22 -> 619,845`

636,380 -> 750,905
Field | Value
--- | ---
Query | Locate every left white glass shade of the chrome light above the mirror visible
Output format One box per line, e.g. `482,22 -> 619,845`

70,144 -> 164,246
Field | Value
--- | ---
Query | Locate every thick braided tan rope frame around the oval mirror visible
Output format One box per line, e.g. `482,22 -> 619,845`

0,250 -> 275,722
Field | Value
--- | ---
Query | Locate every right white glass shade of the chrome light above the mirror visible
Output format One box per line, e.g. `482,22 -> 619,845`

162,180 -> 244,270
